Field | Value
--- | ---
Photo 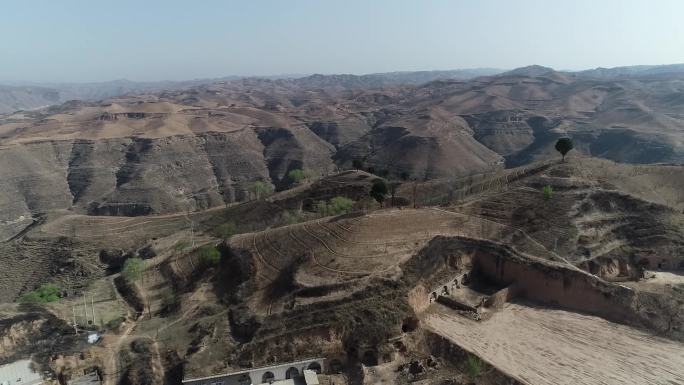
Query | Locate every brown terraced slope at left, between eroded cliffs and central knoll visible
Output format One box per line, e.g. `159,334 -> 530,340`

0,171 -> 375,299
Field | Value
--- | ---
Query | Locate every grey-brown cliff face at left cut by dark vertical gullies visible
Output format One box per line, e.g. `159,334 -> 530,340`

0,129 -> 332,240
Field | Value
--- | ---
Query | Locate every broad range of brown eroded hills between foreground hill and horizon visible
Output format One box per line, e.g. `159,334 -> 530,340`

0,66 -> 684,243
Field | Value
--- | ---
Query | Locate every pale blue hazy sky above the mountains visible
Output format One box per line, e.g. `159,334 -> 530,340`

0,0 -> 684,82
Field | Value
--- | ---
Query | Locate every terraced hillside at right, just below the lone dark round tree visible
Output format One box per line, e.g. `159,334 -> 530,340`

457,159 -> 684,280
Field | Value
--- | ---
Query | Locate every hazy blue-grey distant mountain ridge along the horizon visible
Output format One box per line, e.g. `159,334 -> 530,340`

0,64 -> 684,114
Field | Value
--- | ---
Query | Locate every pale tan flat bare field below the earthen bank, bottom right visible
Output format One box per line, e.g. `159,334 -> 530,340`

425,304 -> 684,385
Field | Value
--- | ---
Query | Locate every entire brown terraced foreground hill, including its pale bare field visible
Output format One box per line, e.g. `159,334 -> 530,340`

0,158 -> 684,384
